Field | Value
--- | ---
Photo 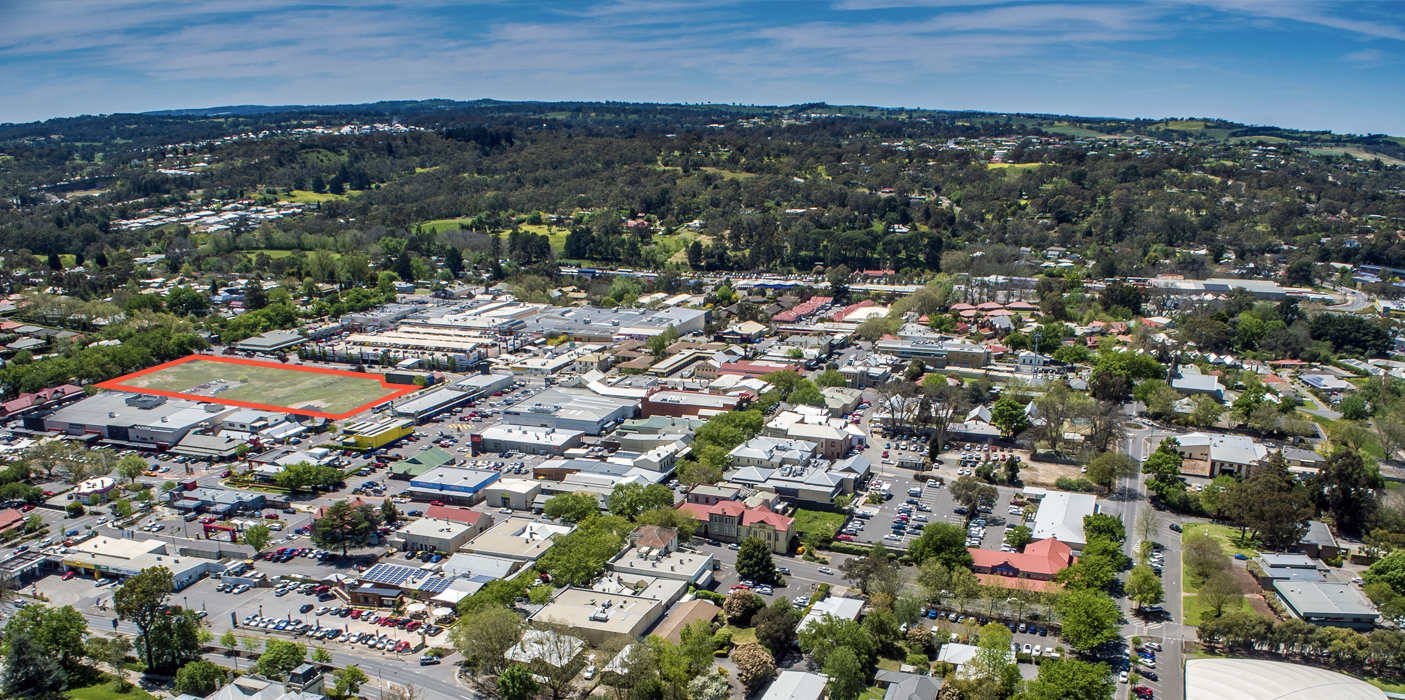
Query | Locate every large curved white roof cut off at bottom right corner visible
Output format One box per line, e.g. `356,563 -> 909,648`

1184,659 -> 1387,700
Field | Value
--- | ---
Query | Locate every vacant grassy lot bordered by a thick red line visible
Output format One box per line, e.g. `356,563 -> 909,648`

122,360 -> 392,413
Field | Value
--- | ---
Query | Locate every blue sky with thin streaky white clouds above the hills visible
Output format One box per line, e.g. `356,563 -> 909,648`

0,0 -> 1405,135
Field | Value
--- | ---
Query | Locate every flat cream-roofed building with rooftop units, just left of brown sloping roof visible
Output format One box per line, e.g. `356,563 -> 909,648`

530,588 -> 665,647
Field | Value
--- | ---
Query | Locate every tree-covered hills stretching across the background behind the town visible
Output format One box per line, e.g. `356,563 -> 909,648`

0,101 -> 1405,295
